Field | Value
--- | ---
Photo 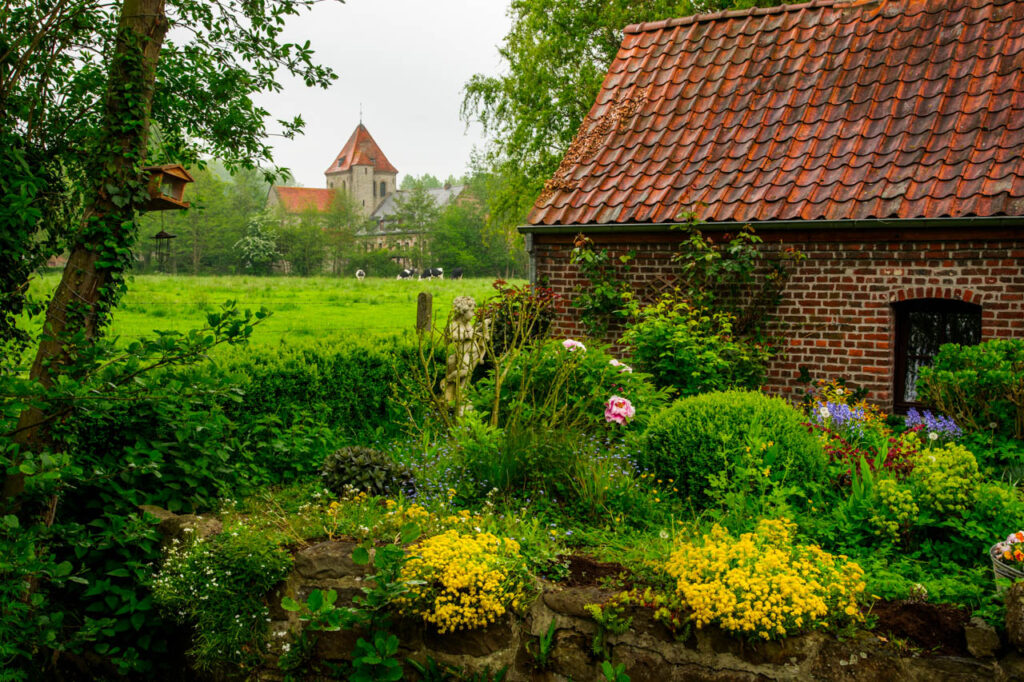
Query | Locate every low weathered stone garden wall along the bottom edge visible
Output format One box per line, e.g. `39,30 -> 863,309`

260,542 -> 1024,682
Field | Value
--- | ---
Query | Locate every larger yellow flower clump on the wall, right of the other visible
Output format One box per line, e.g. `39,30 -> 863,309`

666,519 -> 865,640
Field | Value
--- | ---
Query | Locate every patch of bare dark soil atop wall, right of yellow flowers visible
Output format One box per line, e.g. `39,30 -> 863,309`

871,601 -> 970,656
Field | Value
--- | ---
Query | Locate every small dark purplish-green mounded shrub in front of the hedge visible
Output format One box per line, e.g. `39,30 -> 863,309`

321,445 -> 415,497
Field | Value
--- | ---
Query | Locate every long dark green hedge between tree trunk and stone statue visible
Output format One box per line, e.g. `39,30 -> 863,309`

59,331 -> 428,501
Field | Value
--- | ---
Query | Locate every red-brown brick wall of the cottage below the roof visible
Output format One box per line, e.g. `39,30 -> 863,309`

532,228 -> 1024,409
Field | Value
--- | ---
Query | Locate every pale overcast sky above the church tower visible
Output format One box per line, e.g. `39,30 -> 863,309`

258,0 -> 510,187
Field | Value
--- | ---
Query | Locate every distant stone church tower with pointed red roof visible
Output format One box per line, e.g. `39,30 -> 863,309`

324,121 -> 398,216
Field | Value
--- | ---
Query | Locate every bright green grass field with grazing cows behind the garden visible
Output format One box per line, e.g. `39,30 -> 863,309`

24,273 -> 520,345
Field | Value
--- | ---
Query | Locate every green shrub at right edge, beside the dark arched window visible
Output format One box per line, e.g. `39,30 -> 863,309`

918,339 -> 1024,438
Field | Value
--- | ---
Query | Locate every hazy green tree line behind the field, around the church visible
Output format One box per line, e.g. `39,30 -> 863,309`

136,162 -> 526,278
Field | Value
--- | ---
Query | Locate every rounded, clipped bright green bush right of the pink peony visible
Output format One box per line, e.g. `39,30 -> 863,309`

640,391 -> 825,502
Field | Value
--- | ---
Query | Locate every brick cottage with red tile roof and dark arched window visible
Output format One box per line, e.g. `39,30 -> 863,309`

520,0 -> 1024,410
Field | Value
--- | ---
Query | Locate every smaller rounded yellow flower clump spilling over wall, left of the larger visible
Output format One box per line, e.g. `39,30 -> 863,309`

395,529 -> 528,634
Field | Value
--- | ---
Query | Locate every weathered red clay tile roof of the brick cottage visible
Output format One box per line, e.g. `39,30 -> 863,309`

528,0 -> 1024,225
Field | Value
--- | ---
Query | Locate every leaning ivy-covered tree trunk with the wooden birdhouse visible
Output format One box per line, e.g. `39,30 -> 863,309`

3,0 -> 168,499
